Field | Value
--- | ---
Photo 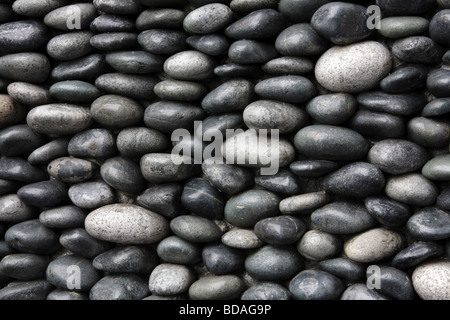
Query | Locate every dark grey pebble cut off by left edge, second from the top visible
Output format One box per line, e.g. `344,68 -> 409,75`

0,20 -> 50,54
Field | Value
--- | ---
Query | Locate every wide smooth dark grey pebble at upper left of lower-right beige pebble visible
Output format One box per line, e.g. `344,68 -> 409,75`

311,201 -> 377,234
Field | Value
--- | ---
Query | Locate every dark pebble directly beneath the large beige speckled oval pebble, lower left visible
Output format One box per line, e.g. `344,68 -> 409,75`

92,245 -> 159,274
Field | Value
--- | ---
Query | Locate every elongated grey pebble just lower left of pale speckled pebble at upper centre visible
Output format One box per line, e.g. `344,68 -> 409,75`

95,73 -> 159,100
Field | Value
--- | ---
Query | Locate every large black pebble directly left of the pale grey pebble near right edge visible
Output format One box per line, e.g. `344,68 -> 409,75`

323,162 -> 386,197
